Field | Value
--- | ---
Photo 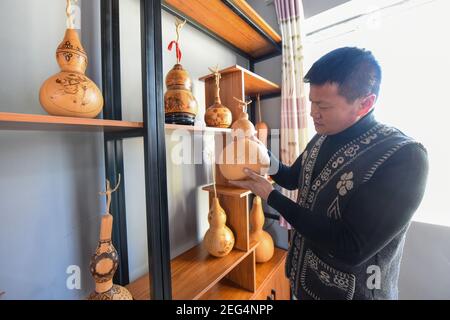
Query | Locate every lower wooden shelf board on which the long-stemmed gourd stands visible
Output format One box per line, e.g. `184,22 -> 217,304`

127,243 -> 257,300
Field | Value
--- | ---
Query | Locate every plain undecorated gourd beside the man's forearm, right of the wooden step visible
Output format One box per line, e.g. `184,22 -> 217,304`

250,196 -> 274,263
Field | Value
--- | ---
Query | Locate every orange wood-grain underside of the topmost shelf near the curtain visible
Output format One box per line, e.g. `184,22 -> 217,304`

164,0 -> 280,58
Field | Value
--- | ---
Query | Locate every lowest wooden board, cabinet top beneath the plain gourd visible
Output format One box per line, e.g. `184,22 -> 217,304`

196,248 -> 286,300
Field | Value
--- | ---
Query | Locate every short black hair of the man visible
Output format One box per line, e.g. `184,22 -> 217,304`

304,47 -> 381,103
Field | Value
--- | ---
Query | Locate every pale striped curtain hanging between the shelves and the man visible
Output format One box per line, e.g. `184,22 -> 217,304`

274,0 -> 308,229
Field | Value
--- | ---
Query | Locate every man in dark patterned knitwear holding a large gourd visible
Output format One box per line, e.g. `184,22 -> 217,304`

232,47 -> 428,299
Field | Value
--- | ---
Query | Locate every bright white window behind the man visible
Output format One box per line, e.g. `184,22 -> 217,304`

305,0 -> 450,226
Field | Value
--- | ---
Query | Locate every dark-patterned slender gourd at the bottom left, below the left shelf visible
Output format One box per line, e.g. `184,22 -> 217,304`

88,175 -> 133,300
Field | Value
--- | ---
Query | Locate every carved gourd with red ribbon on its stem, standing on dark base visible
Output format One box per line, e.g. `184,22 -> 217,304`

164,19 -> 198,125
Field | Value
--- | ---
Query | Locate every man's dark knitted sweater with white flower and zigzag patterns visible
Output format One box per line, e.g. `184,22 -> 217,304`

267,111 -> 428,300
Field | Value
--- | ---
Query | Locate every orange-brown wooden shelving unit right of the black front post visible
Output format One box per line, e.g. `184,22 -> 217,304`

127,0 -> 289,299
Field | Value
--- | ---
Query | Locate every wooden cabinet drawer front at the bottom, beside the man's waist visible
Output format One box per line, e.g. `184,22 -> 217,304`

254,264 -> 290,300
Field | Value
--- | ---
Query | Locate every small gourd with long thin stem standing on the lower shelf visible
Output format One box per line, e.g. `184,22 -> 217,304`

203,151 -> 234,257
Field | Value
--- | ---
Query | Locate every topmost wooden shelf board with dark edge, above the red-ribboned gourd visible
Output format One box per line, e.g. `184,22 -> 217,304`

164,0 -> 281,58
